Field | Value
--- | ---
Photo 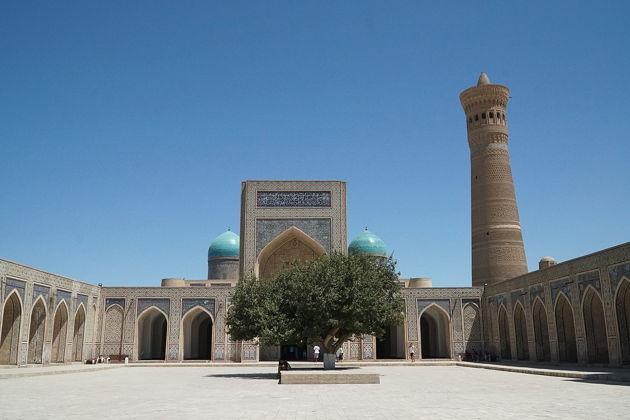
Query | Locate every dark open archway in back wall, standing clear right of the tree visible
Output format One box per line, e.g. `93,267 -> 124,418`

420,305 -> 451,359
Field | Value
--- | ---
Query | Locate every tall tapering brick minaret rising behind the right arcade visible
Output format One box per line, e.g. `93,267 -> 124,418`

459,73 -> 527,286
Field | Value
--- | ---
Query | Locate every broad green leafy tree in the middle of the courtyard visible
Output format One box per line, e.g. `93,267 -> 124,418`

227,253 -> 404,369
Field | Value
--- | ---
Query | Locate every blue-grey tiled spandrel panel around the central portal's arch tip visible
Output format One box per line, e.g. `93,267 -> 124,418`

256,218 -> 331,257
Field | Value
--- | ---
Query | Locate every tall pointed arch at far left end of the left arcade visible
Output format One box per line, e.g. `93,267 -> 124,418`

0,290 -> 22,365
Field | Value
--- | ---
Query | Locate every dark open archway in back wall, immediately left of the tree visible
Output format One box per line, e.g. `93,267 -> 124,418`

183,307 -> 213,360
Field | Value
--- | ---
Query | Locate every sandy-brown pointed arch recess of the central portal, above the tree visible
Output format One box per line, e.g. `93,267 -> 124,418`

254,226 -> 326,278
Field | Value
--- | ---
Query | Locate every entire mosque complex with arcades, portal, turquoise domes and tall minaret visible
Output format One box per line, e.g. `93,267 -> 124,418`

0,74 -> 630,366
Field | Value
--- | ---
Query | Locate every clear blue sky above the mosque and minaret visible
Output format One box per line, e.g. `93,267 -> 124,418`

0,1 -> 630,286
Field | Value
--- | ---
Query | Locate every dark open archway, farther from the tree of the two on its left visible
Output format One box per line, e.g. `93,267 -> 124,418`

138,307 -> 167,360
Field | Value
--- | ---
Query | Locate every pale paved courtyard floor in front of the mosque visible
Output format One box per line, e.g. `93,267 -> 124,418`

0,366 -> 630,420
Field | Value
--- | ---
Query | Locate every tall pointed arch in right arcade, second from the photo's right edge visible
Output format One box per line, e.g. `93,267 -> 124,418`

582,285 -> 609,363
